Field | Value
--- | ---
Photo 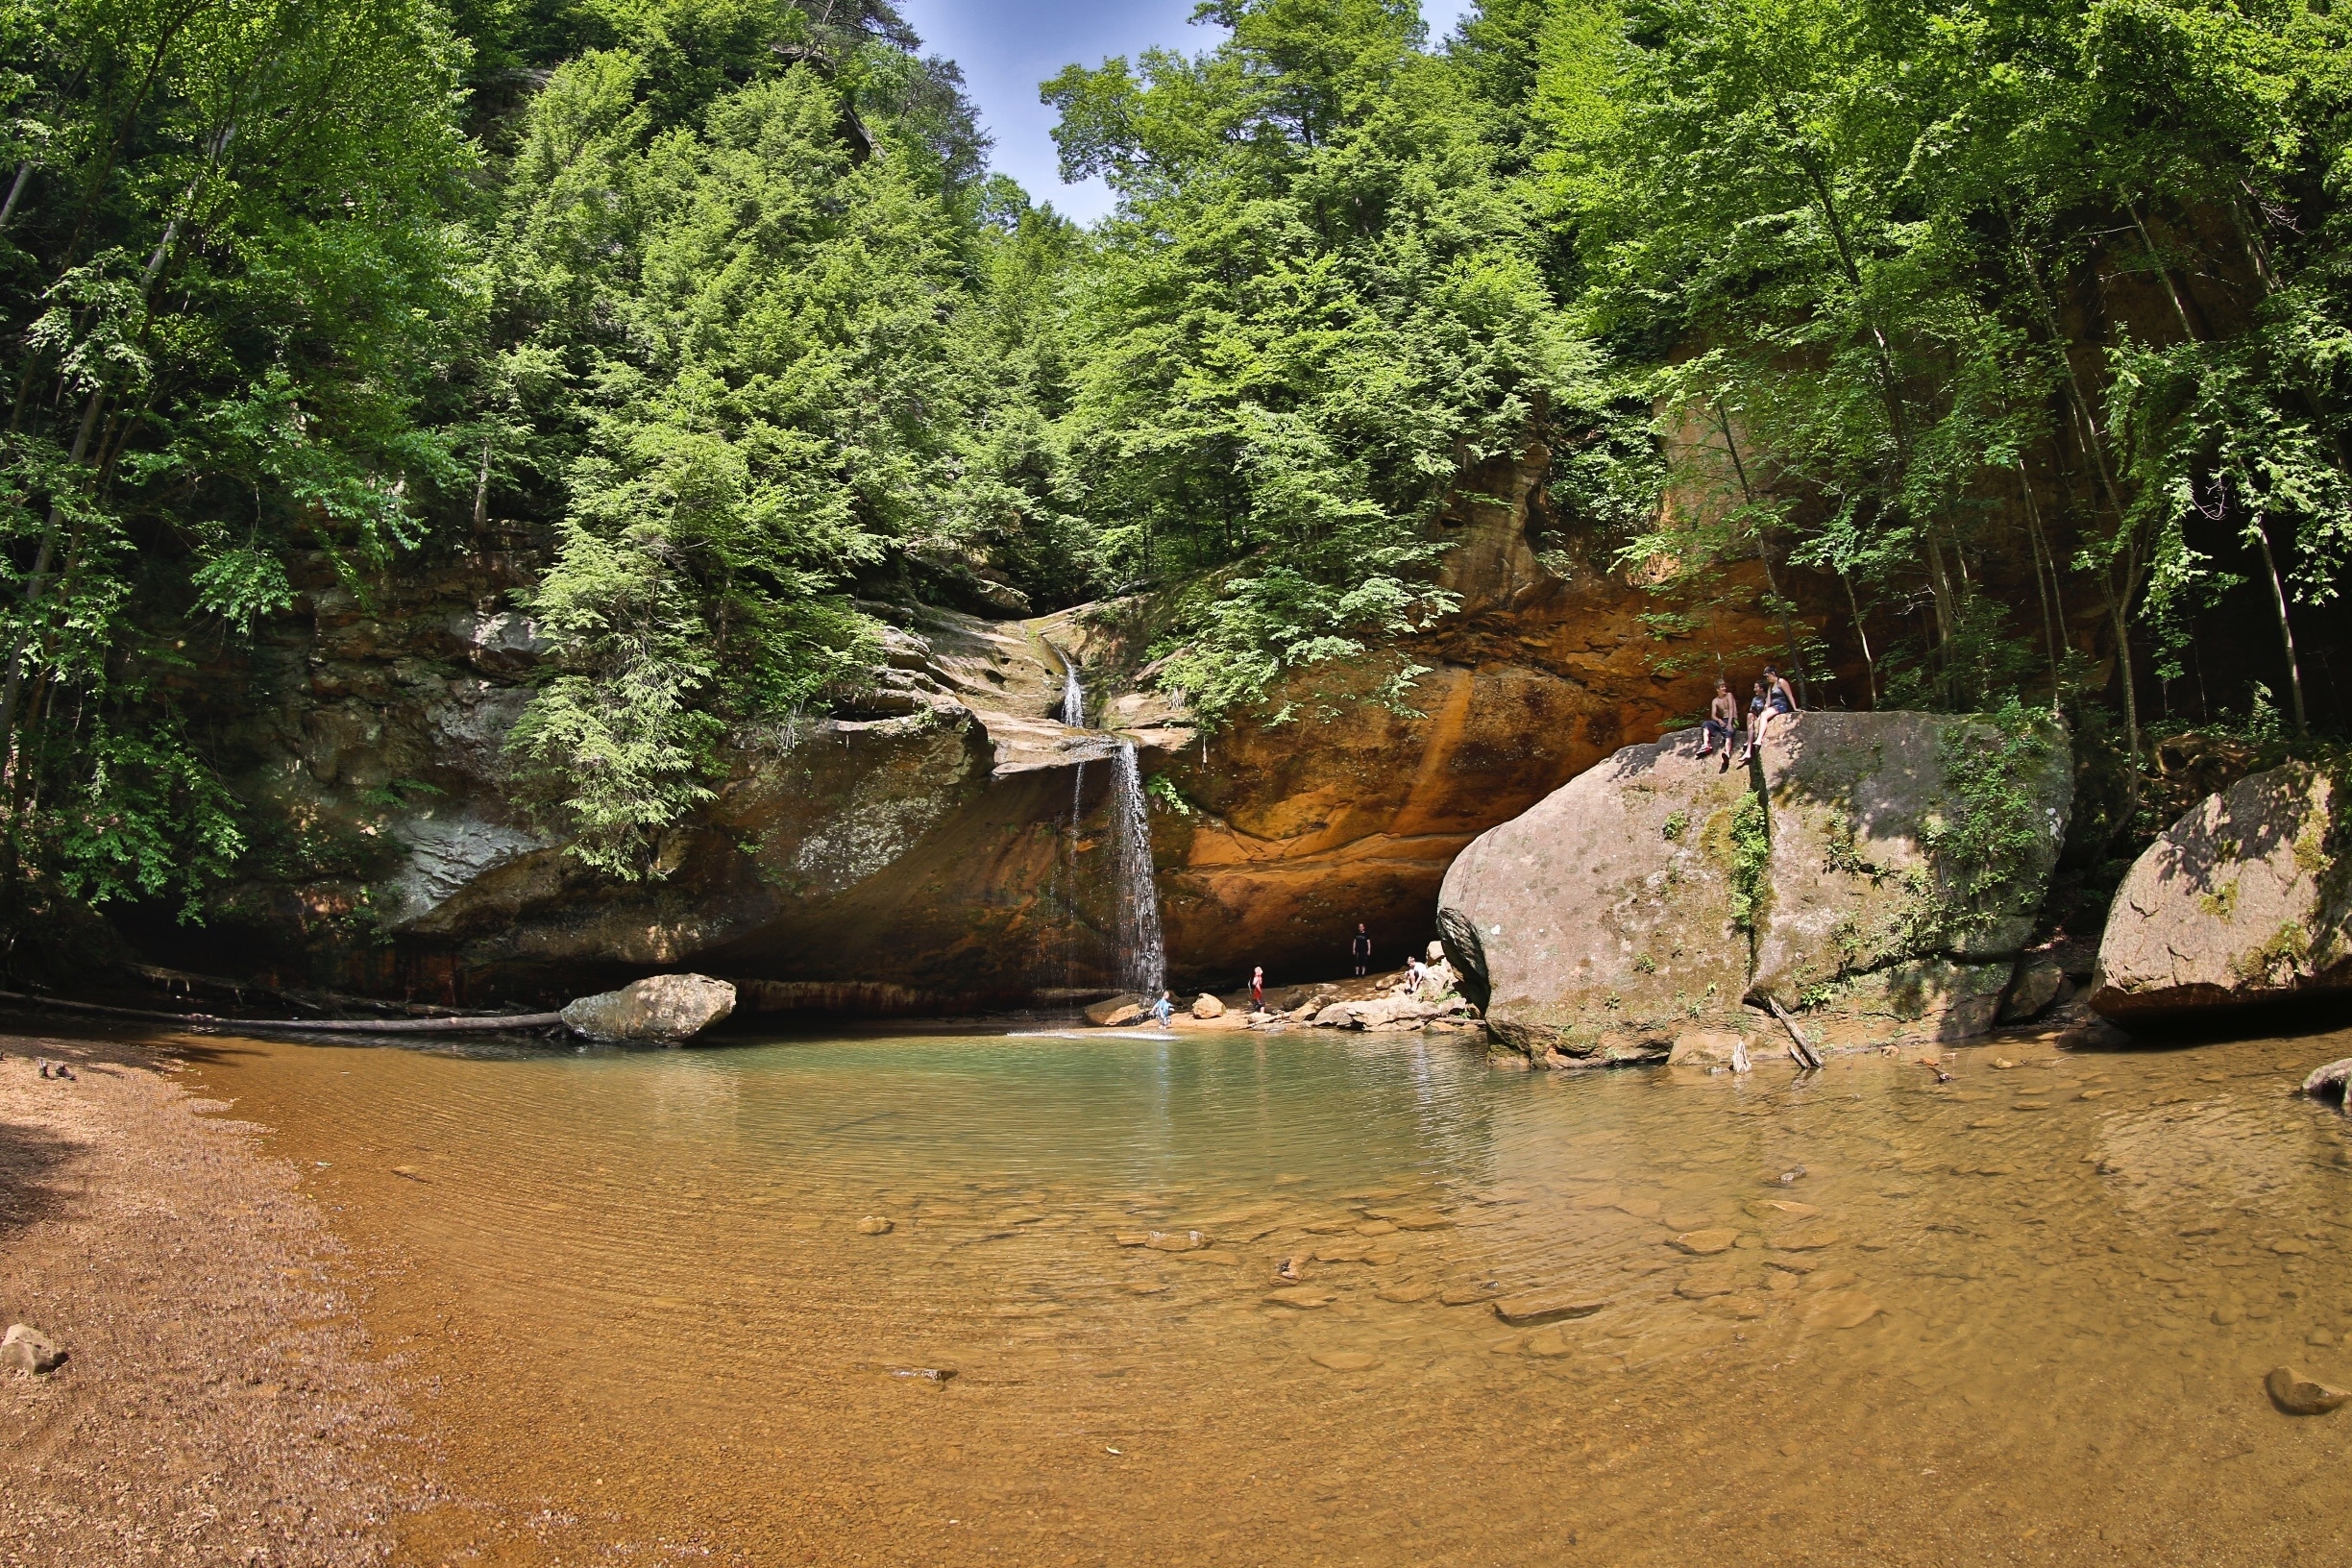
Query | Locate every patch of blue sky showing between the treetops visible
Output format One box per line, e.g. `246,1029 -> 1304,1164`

898,0 -> 1468,221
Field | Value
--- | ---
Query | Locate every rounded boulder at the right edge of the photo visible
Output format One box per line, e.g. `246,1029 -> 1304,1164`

2091,764 -> 2352,1020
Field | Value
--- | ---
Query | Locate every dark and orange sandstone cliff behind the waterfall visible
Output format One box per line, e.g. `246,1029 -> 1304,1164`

135,449 -> 1780,1011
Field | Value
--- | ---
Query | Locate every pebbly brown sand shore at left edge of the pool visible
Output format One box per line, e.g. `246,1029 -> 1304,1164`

0,1035 -> 416,1568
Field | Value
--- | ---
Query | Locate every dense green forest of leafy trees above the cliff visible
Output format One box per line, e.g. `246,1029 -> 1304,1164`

0,0 -> 2352,944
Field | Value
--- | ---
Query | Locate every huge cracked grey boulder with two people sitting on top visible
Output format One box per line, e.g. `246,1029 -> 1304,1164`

1437,712 -> 2072,1065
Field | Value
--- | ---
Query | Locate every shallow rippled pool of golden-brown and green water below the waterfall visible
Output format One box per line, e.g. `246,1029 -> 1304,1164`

197,1032 -> 2352,1563
